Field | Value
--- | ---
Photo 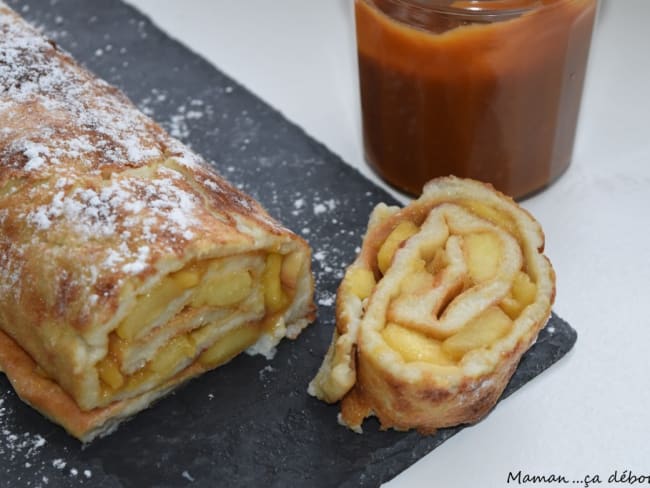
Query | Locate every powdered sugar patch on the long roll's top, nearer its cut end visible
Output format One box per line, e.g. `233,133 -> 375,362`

19,167 -> 200,277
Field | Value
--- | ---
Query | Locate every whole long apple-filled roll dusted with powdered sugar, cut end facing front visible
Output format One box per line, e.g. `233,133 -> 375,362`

0,3 -> 314,441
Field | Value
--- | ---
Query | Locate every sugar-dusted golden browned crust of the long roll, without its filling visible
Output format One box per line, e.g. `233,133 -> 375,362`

0,2 -> 315,435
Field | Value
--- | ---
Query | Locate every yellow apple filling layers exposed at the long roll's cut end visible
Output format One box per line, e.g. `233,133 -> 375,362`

97,252 -> 305,400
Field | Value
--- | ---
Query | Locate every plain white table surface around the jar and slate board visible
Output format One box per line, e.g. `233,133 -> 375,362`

130,0 -> 650,488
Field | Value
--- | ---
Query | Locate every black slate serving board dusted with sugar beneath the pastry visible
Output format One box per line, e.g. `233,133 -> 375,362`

0,0 -> 576,487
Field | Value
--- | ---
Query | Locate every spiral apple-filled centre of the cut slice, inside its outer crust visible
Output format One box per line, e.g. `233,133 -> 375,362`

346,204 -> 537,366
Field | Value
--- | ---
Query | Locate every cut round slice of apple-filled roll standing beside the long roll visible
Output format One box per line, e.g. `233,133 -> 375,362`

309,177 -> 555,433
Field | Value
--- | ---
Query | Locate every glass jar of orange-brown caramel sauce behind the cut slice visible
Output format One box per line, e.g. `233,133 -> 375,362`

355,0 -> 597,198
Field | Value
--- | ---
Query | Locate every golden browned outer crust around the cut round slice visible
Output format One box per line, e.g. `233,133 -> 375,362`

309,177 -> 555,434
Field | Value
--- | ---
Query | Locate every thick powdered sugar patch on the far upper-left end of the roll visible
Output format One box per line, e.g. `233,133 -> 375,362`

0,6 -> 170,172
